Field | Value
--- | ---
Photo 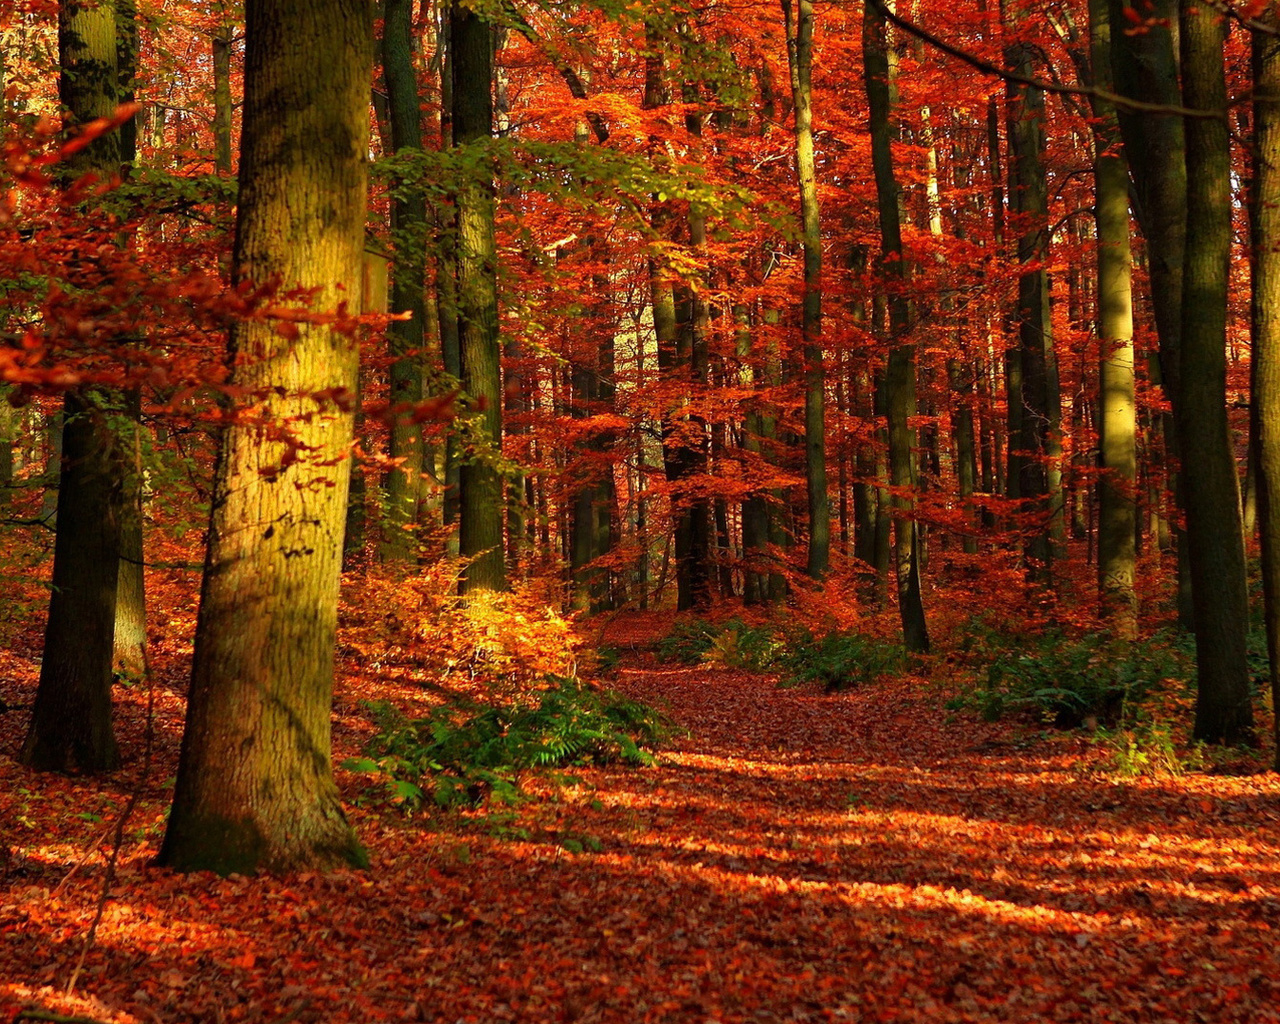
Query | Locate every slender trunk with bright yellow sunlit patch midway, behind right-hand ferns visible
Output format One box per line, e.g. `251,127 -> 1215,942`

1089,0 -> 1138,640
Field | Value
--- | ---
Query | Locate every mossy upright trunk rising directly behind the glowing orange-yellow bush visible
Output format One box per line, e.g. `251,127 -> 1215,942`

449,0 -> 507,594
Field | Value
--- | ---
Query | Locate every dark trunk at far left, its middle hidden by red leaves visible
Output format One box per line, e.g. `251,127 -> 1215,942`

20,0 -> 120,772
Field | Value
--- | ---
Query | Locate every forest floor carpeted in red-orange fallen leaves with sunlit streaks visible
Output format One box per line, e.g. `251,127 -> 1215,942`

0,604 -> 1280,1024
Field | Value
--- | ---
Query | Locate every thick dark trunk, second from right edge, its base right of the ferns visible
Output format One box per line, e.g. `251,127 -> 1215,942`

1175,0 -> 1253,744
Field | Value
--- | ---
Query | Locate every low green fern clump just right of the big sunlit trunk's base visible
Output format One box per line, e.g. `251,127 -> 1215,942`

343,678 -> 677,810
